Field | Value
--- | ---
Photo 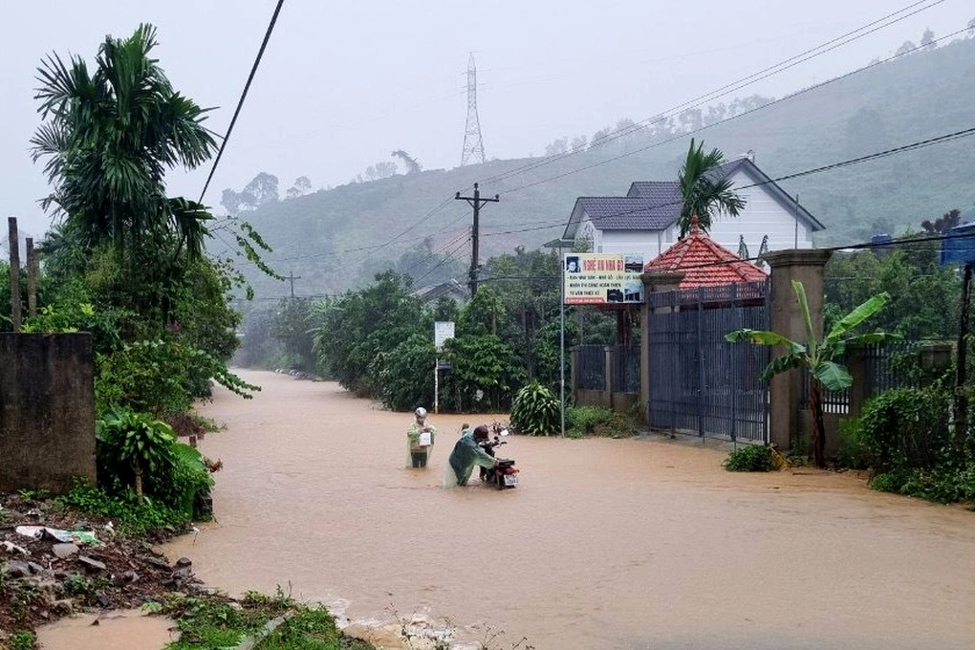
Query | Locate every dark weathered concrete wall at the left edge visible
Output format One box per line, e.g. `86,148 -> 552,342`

0,333 -> 95,493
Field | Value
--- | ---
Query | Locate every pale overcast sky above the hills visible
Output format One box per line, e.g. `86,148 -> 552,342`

0,0 -> 974,237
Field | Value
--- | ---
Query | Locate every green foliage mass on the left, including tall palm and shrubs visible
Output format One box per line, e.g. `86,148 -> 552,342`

0,26 -> 263,535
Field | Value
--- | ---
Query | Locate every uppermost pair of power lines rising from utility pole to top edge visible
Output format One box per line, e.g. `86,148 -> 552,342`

485,0 -> 945,185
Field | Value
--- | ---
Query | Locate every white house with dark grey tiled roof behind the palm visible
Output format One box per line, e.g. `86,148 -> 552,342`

562,156 -> 824,259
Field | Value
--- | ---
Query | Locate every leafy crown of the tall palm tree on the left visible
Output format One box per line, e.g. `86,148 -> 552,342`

31,25 -> 216,257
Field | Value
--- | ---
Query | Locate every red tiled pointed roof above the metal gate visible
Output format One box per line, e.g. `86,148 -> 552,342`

644,214 -> 767,289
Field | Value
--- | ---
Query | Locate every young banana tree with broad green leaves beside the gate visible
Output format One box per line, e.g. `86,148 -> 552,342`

726,280 -> 901,467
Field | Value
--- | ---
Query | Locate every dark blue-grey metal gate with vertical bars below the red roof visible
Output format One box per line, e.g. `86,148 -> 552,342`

647,281 -> 770,443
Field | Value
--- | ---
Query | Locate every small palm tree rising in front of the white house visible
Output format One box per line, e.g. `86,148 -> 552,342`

678,138 -> 746,238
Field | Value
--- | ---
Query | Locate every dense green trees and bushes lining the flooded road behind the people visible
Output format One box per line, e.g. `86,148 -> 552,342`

286,249 -> 613,412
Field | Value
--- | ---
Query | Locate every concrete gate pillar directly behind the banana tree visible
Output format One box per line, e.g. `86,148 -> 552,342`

764,249 -> 831,450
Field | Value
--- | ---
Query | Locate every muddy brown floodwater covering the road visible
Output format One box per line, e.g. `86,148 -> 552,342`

164,371 -> 974,650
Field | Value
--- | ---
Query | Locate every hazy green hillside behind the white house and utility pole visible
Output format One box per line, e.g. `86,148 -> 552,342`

215,38 -> 975,297
